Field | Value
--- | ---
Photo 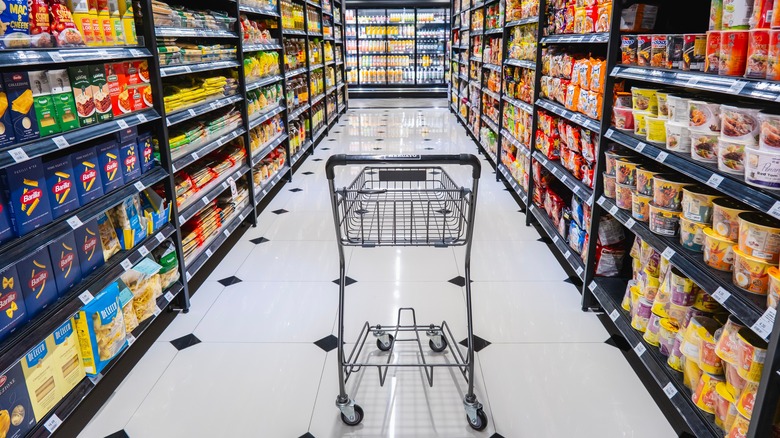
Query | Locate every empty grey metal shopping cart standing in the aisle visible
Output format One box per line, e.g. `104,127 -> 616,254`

326,154 -> 487,430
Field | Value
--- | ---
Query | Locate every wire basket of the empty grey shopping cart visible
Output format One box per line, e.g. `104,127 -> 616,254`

336,167 -> 473,246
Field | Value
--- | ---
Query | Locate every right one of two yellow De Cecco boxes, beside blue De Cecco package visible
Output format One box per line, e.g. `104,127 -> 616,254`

46,318 -> 86,398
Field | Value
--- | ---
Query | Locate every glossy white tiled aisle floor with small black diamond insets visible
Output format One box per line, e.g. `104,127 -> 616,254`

81,101 -> 675,438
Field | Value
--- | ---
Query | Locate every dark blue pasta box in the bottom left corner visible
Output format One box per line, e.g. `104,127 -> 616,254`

0,362 -> 36,438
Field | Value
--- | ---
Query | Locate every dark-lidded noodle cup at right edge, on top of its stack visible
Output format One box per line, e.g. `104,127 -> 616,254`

738,212 -> 780,263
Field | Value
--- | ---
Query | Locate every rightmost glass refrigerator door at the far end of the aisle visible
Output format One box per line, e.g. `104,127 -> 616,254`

416,9 -> 449,84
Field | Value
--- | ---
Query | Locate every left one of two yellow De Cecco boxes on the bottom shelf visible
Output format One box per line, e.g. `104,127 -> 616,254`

21,339 -> 60,421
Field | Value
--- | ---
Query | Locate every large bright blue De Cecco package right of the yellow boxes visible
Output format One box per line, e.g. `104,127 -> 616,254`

74,282 -> 127,376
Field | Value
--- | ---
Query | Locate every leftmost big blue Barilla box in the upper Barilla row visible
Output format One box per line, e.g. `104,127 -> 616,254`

0,158 -> 52,236
